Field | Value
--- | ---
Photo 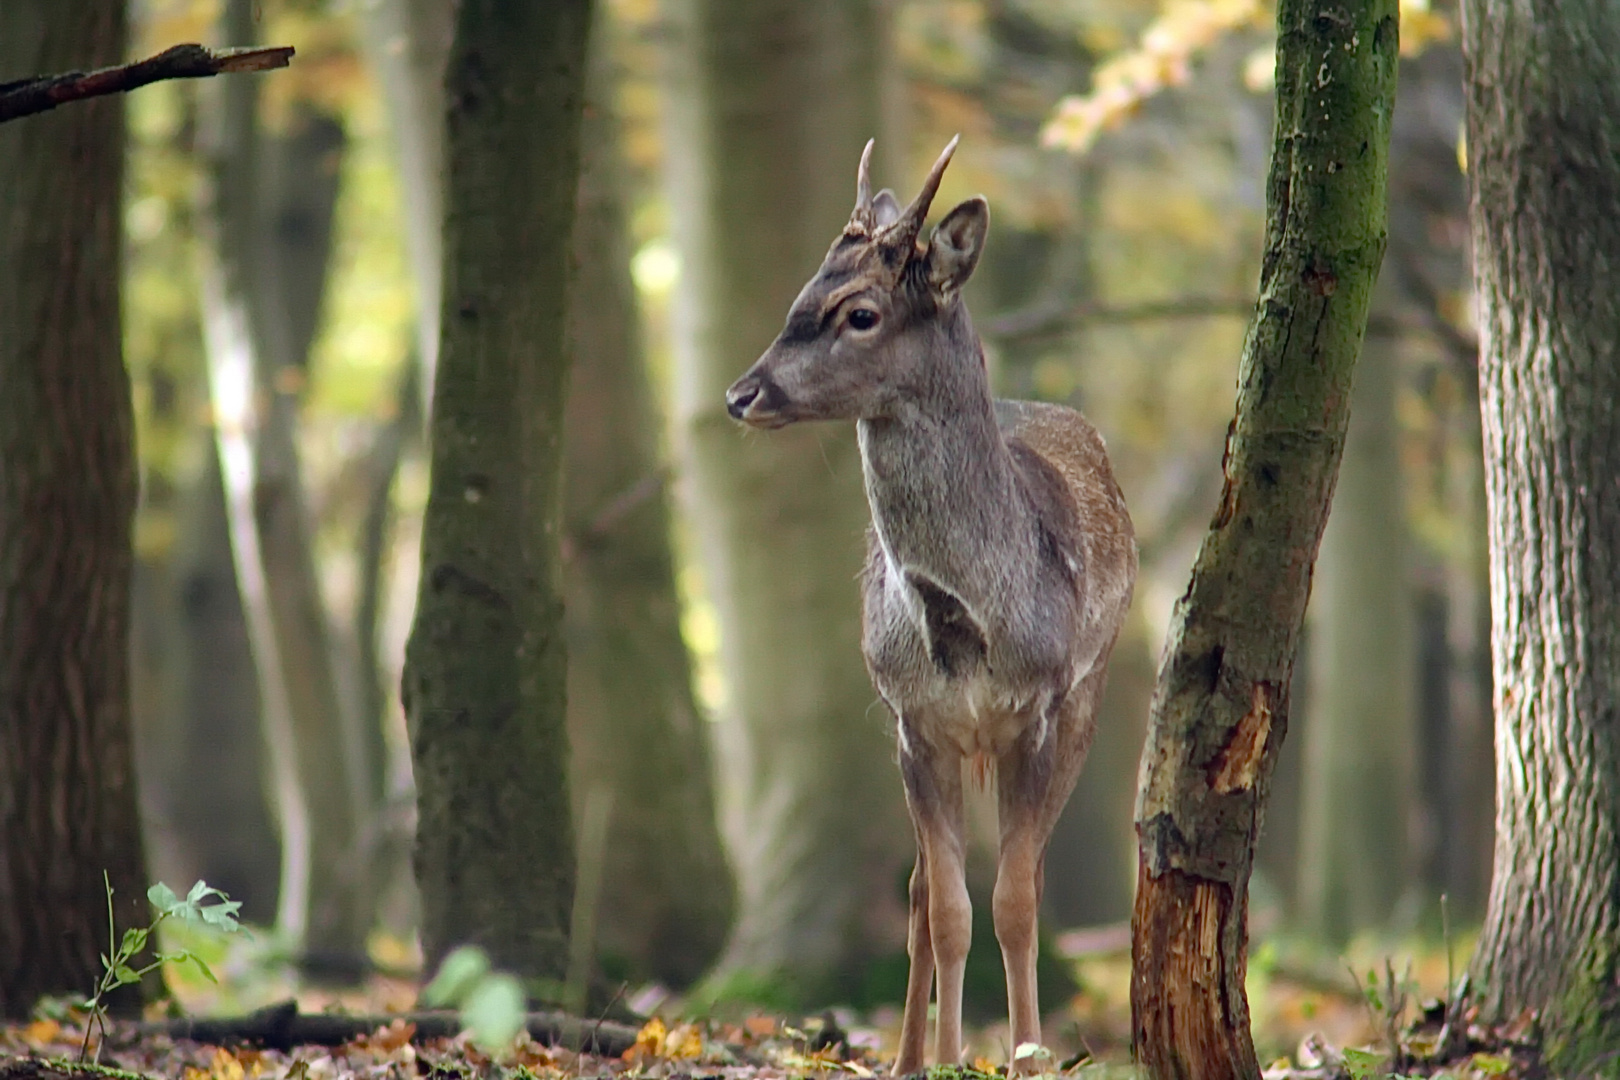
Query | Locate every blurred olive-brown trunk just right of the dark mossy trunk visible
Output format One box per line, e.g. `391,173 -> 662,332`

564,29 -> 732,986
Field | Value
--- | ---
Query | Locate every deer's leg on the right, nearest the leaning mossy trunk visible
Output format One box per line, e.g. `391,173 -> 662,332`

993,670 -> 1102,1072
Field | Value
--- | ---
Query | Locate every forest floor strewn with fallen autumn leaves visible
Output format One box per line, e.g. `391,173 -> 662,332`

0,941 -> 1539,1080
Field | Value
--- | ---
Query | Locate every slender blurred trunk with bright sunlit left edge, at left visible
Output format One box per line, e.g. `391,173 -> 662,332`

204,0 -> 371,970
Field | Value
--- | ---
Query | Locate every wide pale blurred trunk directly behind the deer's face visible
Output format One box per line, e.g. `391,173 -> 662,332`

666,0 -> 910,1004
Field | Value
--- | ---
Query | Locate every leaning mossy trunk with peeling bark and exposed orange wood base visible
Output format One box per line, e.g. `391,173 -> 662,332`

1131,0 -> 1398,1080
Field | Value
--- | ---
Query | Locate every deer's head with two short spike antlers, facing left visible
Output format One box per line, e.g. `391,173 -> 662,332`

726,139 -> 990,427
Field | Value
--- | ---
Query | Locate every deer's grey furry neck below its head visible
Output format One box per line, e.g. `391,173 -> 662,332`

857,300 -> 1032,614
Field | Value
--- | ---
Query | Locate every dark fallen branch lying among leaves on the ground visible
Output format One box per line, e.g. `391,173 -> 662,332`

138,1001 -> 637,1057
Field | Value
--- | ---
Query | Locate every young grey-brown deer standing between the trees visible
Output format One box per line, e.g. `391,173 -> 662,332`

726,138 -> 1137,1075
